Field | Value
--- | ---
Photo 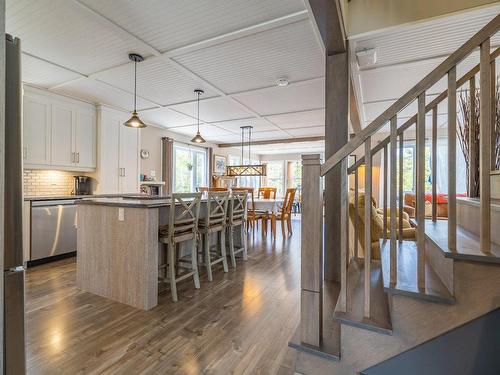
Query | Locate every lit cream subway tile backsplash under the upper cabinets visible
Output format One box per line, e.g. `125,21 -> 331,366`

24,169 -> 85,197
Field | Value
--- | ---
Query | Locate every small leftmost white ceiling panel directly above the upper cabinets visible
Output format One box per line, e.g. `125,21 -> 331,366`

21,54 -> 81,88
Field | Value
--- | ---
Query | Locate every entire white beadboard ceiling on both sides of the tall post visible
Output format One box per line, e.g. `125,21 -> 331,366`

6,0 -> 500,154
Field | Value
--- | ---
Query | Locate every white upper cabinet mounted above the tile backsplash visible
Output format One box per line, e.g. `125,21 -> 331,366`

23,88 -> 97,171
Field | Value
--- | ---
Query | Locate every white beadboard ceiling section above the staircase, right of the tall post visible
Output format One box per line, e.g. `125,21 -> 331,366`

350,3 -> 500,131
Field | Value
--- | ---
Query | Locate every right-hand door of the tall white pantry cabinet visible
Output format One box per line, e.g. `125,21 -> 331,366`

120,125 -> 139,194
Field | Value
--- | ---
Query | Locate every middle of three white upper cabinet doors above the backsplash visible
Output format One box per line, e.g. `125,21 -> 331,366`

51,104 -> 76,167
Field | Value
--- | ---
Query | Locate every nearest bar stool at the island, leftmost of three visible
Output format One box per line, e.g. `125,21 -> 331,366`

159,193 -> 201,302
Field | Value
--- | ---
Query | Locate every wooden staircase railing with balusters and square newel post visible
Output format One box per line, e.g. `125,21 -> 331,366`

301,14 -> 500,352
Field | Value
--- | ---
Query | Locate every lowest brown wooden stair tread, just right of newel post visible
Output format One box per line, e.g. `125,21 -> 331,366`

333,259 -> 392,335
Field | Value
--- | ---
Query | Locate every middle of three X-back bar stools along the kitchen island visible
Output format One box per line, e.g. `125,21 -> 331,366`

198,191 -> 229,281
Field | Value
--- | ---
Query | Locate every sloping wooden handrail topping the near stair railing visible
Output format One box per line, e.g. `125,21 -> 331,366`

321,14 -> 500,176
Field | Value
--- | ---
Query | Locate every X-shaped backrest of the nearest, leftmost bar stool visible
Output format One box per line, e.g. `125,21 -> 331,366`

168,193 -> 201,237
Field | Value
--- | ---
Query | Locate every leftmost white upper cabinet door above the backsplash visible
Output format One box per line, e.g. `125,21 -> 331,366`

23,95 -> 50,166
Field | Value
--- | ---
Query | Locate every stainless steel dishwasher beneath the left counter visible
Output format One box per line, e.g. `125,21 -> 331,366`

30,199 -> 77,260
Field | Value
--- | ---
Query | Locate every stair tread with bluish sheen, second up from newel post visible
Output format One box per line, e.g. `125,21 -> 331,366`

380,240 -> 455,304
